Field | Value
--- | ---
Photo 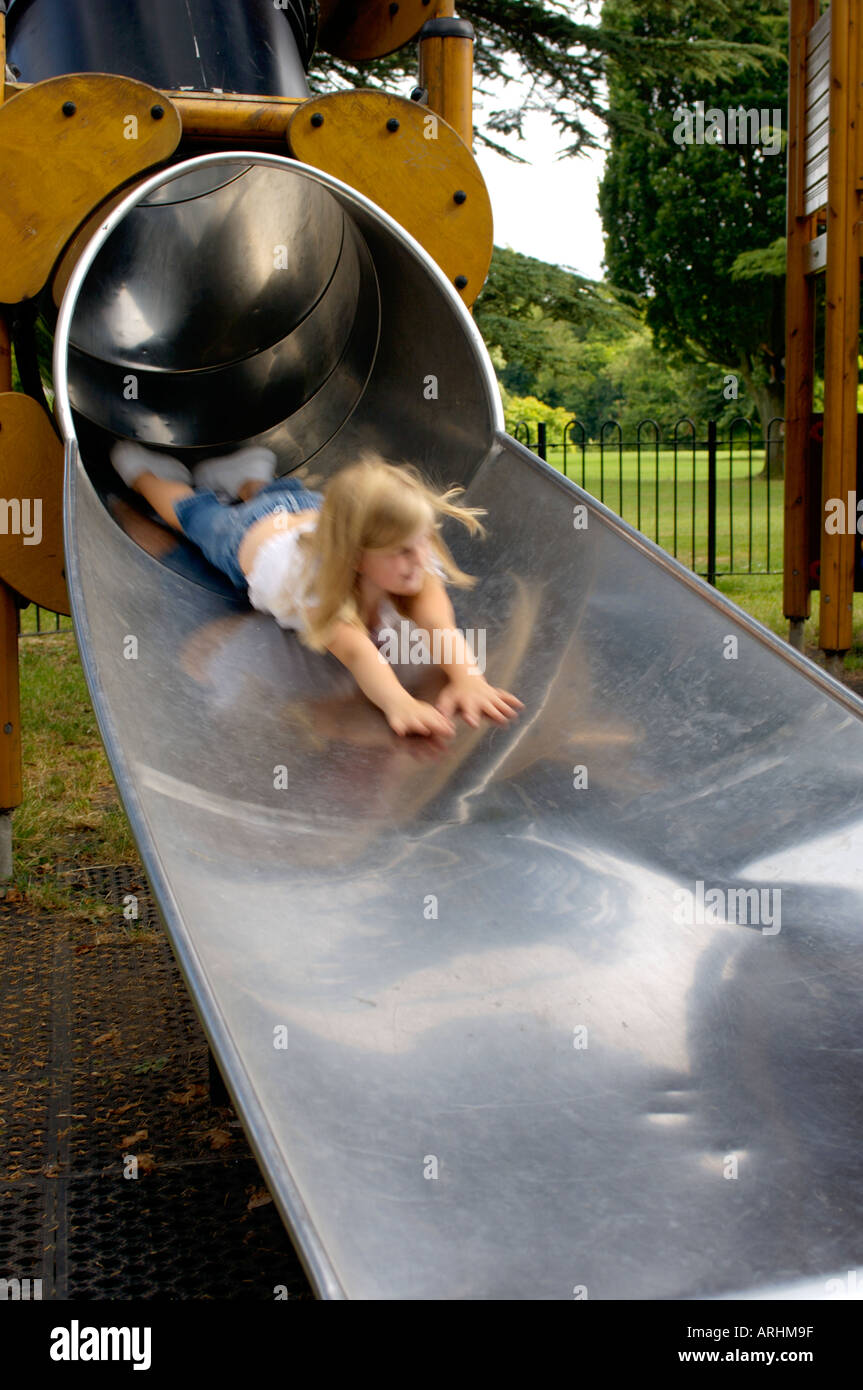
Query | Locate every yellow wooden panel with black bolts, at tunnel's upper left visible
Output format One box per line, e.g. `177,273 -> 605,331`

0,72 -> 182,304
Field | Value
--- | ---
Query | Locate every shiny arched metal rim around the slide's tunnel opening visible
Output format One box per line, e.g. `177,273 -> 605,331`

53,150 -> 504,441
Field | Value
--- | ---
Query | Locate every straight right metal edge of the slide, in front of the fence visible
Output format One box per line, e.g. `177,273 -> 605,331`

495,430 -> 863,719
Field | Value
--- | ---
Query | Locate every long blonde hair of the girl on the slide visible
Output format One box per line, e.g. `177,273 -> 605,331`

282,449 -> 485,652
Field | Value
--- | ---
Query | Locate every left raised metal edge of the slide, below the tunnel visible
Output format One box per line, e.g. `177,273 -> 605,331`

64,439 -> 346,1301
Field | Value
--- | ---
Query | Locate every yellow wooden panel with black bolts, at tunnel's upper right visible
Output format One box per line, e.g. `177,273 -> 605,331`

288,90 -> 493,304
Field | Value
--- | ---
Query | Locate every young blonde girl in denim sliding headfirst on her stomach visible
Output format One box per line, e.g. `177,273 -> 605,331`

111,441 -> 524,738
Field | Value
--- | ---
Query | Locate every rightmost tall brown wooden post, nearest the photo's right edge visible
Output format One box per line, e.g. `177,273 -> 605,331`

819,0 -> 860,658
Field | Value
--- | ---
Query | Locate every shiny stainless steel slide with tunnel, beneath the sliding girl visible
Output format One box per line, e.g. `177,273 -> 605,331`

56,154 -> 863,1300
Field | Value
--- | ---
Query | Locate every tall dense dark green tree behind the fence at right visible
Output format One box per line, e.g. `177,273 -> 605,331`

600,0 -> 788,471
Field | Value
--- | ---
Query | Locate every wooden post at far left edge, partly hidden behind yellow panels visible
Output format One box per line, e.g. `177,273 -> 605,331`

0,0 -> 24,883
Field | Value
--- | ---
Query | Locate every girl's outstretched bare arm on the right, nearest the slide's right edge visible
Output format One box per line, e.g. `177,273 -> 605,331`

404,574 -> 524,728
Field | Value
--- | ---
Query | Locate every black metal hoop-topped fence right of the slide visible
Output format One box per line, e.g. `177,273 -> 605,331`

513,416 -> 784,584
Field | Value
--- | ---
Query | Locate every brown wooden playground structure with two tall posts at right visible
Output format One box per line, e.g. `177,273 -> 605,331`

784,0 -> 863,674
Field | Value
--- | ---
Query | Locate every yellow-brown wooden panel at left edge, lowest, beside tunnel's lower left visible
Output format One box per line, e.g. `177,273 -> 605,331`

0,391 -> 69,614
